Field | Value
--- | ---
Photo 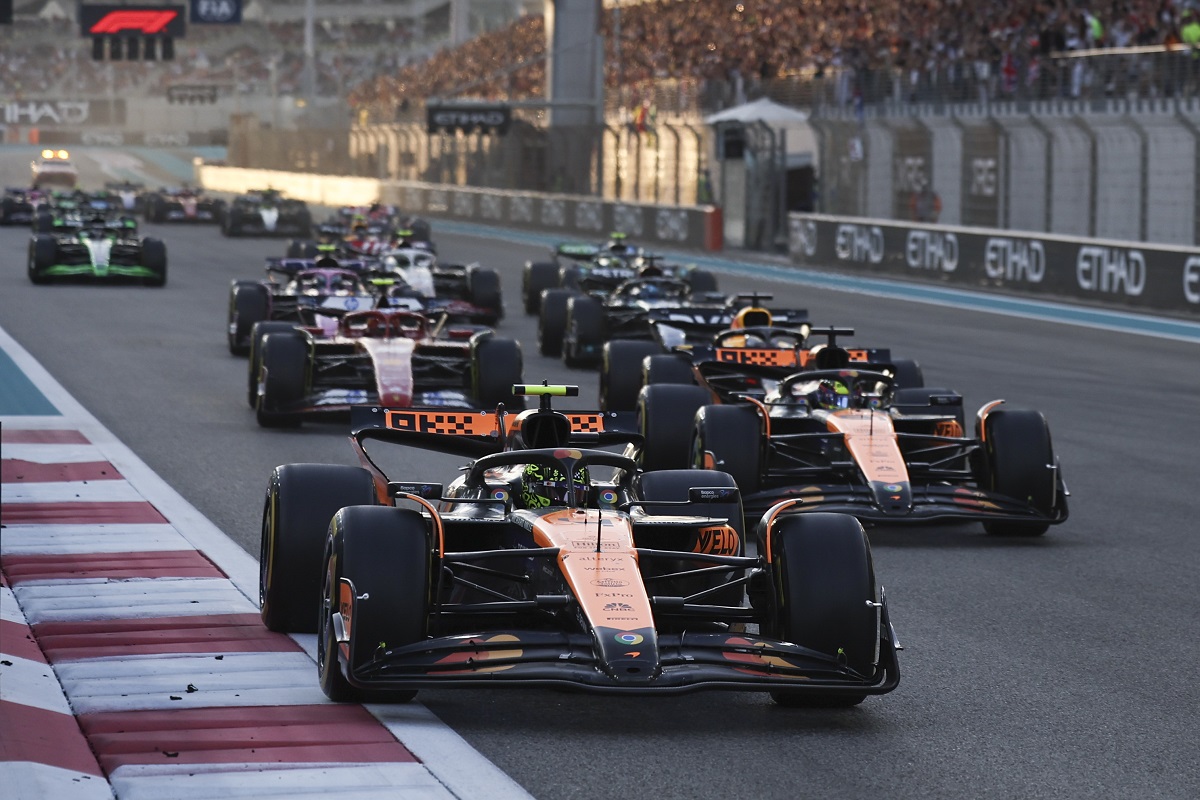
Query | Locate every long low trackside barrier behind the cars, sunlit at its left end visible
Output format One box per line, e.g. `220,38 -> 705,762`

196,162 -> 724,251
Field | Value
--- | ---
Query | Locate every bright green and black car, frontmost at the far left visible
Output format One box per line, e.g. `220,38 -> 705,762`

29,218 -> 167,287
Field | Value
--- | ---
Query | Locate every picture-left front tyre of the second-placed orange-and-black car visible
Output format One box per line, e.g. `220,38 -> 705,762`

691,405 -> 762,494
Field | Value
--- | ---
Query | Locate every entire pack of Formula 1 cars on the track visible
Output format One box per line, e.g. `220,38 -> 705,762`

14,165 -> 1068,706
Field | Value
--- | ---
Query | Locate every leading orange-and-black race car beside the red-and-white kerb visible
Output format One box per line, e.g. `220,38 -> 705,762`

259,385 -> 899,706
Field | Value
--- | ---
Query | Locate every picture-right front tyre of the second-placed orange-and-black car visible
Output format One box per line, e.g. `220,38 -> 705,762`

979,408 -> 1058,536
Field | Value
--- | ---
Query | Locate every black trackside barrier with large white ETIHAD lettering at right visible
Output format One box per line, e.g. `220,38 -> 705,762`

788,213 -> 1200,315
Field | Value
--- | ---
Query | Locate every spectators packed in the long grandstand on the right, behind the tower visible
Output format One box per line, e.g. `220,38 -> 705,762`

350,0 -> 1200,119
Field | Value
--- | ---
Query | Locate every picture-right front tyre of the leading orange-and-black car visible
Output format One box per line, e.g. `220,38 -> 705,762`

763,512 -> 880,708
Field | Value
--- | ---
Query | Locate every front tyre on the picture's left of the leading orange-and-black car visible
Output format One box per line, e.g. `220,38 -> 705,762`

314,506 -> 433,703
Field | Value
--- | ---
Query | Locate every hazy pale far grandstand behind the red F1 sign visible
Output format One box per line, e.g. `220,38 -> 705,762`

0,0 -> 540,98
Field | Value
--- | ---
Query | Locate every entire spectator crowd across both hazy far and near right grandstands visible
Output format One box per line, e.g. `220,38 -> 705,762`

7,0 -> 1200,113
